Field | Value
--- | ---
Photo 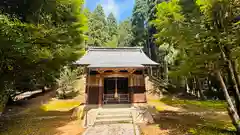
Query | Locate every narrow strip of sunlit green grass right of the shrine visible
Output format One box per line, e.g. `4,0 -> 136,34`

159,97 -> 226,111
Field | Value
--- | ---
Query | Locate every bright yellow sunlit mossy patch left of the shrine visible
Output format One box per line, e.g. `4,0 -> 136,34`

41,100 -> 81,111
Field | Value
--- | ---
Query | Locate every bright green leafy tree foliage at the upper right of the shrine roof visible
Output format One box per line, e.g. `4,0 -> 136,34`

153,0 -> 240,131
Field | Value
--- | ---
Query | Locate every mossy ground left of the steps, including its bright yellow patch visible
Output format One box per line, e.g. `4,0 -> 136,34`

0,100 -> 83,135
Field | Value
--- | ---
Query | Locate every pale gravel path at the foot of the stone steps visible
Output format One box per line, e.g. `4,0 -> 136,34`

83,124 -> 140,135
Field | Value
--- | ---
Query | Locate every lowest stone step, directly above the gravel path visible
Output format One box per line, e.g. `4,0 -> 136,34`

94,118 -> 132,125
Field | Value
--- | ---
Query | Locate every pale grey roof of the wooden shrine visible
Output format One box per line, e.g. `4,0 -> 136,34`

75,47 -> 158,67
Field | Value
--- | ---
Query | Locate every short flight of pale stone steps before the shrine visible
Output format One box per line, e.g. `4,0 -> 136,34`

94,108 -> 133,125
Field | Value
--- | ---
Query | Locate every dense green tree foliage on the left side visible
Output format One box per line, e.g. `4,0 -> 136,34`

0,0 -> 86,110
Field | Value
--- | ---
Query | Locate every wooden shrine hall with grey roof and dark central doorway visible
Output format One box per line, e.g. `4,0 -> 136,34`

75,47 -> 158,106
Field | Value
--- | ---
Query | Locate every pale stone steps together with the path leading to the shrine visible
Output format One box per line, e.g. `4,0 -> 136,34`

83,107 -> 140,135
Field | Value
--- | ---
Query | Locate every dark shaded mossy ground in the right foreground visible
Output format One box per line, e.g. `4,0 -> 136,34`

149,111 -> 235,135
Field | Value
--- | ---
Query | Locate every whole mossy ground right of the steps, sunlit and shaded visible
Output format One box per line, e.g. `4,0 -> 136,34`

141,97 -> 235,135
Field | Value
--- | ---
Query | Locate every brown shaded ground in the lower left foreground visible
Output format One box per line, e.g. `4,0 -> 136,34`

0,108 -> 78,135
